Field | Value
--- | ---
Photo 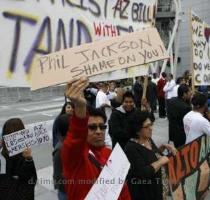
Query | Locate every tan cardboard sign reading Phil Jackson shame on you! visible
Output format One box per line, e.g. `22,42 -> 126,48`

32,28 -> 168,90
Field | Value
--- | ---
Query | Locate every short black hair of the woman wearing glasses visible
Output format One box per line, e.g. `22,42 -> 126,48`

126,110 -> 152,138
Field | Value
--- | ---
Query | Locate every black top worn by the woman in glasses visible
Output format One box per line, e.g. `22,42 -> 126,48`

125,140 -> 162,200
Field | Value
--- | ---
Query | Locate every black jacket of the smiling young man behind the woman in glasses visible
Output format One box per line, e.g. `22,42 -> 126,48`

109,106 -> 135,149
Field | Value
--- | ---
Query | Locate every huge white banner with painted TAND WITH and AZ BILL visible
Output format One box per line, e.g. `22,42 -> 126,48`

0,0 -> 157,87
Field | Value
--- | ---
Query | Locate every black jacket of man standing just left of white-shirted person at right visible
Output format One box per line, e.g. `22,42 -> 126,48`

168,97 -> 191,147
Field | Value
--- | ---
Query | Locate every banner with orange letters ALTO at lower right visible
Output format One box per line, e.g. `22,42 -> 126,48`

168,135 -> 210,200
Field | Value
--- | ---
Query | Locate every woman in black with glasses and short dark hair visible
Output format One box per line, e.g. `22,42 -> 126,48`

125,111 -> 176,200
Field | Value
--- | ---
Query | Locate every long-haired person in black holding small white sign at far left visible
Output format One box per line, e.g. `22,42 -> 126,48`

0,118 -> 37,200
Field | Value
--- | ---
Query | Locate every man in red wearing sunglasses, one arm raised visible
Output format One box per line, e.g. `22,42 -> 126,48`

61,78 -> 130,200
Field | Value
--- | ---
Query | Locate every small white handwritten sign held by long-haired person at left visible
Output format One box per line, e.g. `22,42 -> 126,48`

3,122 -> 50,156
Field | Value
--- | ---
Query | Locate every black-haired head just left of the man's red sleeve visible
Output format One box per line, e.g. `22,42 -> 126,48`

56,114 -> 70,139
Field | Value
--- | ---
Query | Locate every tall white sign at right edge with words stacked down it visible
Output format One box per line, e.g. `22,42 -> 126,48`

192,12 -> 210,85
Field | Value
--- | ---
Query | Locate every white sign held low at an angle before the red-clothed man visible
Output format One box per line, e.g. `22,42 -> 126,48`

85,144 -> 130,200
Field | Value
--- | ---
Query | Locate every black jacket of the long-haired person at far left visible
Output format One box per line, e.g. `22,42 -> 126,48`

0,154 -> 37,200
